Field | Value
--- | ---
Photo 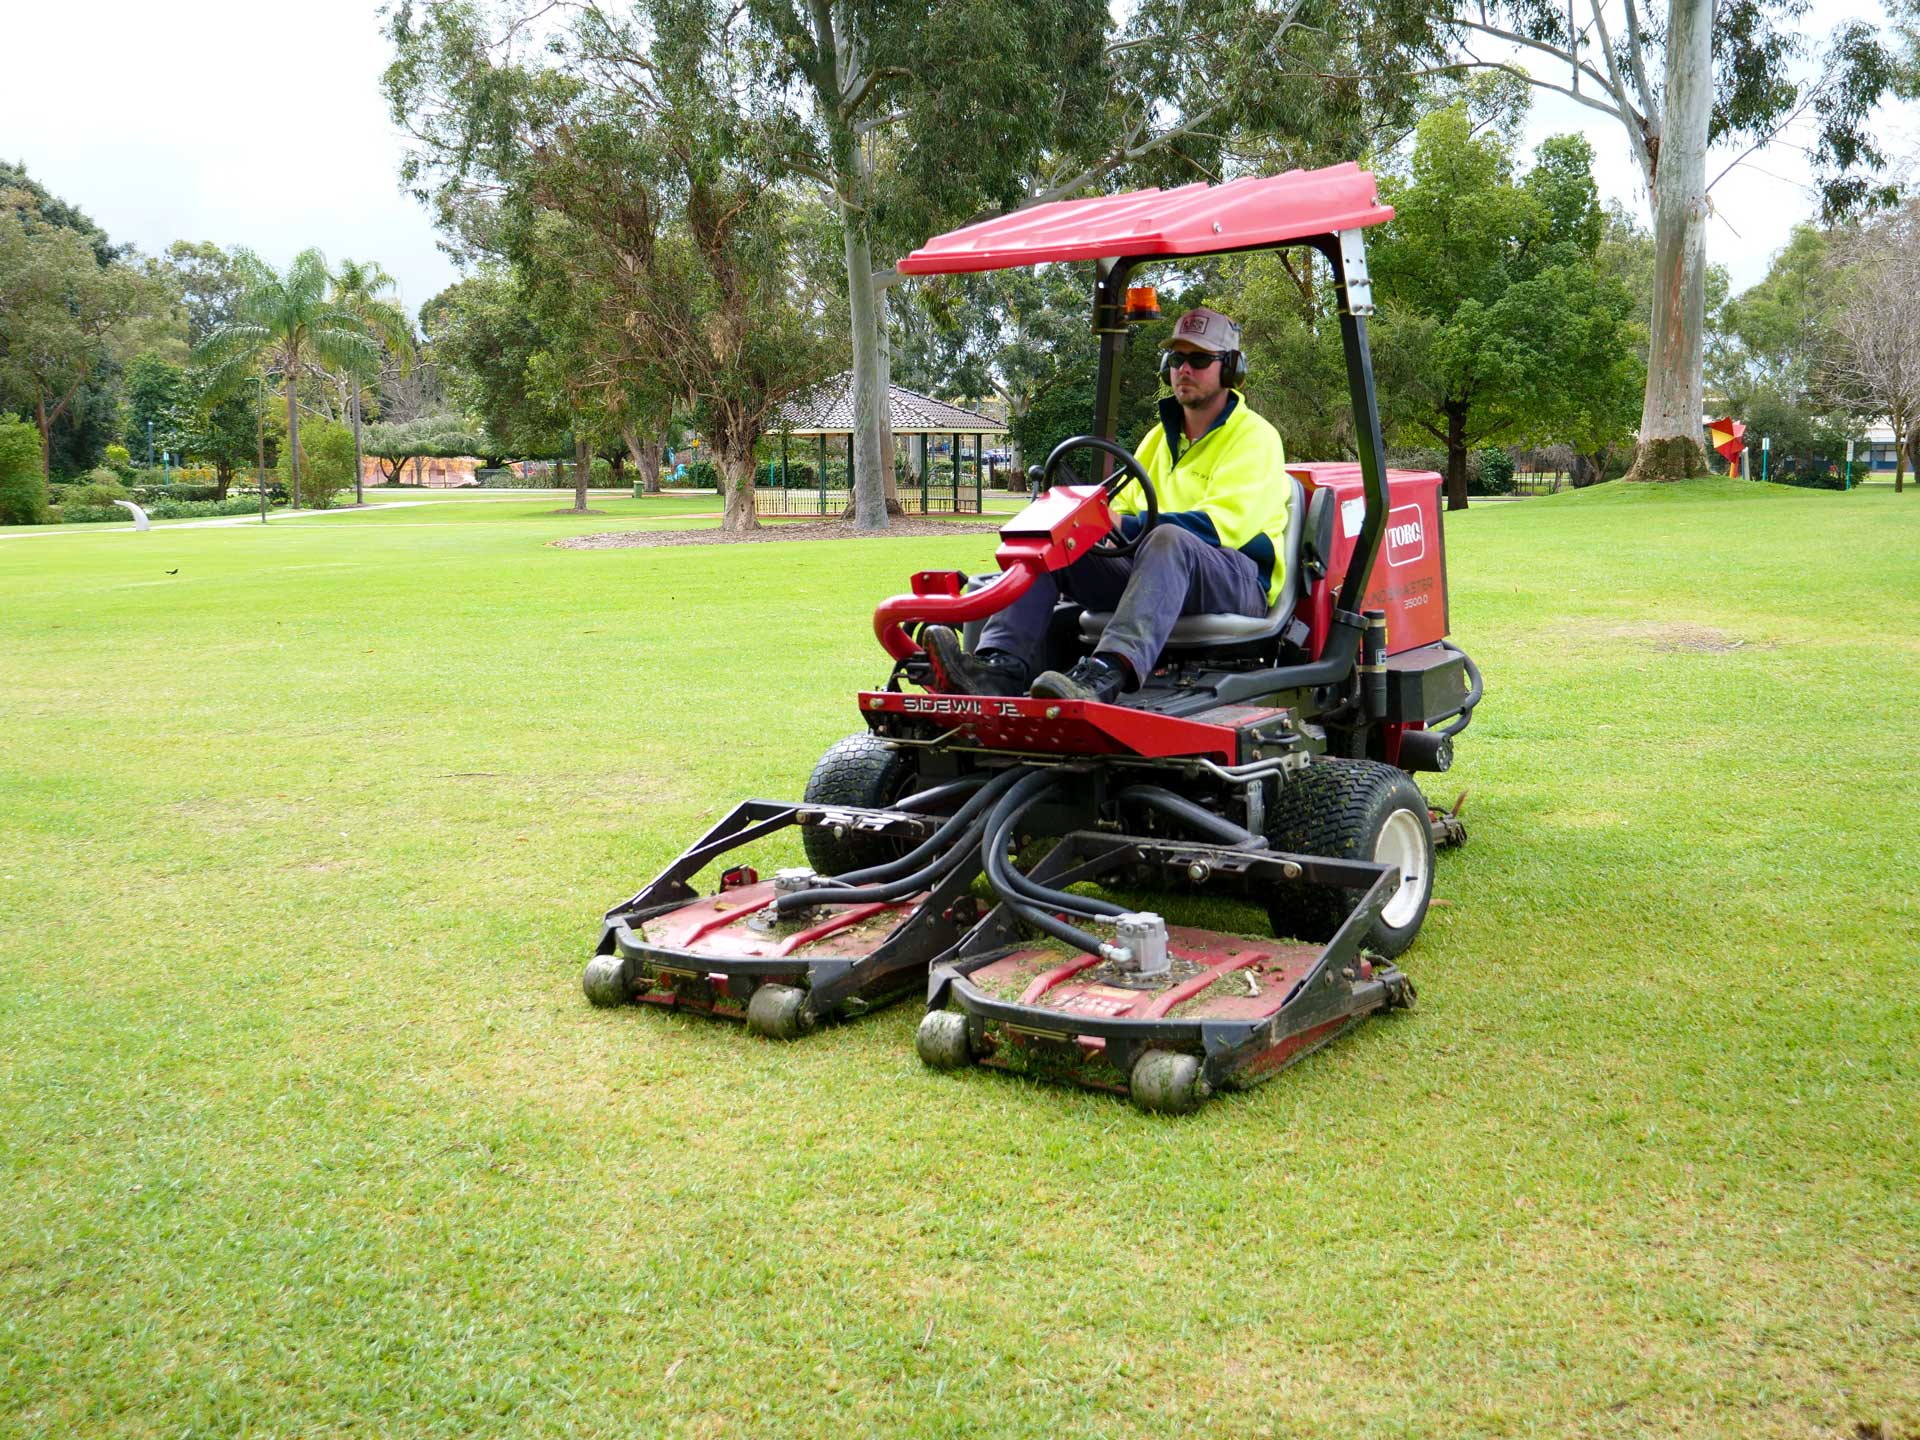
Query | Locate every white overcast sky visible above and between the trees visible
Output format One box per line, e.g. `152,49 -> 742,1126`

0,0 -> 1920,324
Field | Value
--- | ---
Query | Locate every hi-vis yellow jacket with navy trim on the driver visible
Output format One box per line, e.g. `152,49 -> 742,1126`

1114,390 -> 1294,605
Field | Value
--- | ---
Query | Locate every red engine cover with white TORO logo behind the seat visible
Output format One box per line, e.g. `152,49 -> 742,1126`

1286,463 -> 1448,659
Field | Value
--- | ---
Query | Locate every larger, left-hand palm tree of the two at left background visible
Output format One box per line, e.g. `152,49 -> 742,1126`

194,250 -> 380,507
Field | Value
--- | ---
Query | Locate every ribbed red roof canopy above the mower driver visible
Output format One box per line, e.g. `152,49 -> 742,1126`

900,165 -> 1394,275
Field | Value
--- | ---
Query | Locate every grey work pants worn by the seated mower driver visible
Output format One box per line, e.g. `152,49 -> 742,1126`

977,524 -> 1267,682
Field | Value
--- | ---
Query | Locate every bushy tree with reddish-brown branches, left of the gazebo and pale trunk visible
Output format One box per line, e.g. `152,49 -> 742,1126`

507,102 -> 843,530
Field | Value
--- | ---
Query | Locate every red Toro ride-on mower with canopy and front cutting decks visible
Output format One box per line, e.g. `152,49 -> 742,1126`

586,165 -> 1480,1112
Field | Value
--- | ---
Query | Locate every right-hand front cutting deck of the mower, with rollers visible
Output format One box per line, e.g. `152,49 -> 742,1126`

916,831 -> 1413,1114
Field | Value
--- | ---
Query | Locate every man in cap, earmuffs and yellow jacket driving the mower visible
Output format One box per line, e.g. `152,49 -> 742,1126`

922,309 -> 1292,701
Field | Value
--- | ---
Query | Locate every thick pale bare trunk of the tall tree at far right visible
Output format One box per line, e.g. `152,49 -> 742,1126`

1626,0 -> 1713,480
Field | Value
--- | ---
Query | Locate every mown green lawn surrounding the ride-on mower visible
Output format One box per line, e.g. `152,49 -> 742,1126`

0,484 -> 1920,1438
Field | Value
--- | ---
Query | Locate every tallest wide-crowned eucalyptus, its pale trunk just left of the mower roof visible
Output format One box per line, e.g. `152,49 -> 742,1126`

386,0 -> 1432,530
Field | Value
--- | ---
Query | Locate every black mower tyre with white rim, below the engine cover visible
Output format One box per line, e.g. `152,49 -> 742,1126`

1267,760 -> 1434,960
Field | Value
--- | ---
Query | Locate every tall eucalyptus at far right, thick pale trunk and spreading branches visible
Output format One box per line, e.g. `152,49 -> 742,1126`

1413,0 -> 1920,478
